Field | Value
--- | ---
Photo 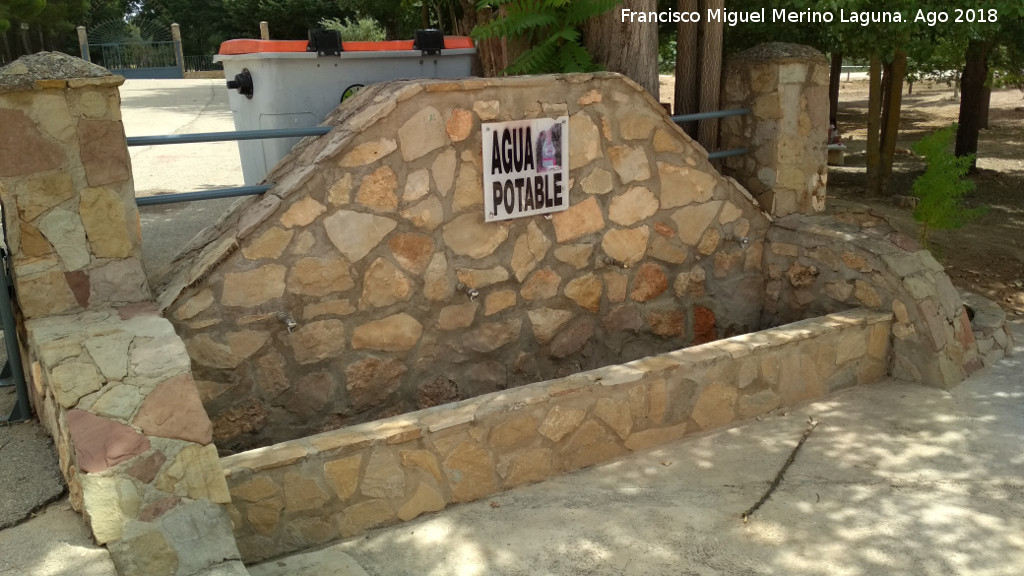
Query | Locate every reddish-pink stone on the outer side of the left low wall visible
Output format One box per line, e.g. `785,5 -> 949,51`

68,409 -> 150,472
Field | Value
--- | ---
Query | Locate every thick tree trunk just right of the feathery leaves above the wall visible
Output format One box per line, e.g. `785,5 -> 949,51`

585,0 -> 659,95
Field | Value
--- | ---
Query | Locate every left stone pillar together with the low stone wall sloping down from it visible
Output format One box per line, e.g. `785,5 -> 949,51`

0,52 -> 246,576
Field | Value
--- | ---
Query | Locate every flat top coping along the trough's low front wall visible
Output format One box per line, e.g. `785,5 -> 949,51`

220,308 -> 893,478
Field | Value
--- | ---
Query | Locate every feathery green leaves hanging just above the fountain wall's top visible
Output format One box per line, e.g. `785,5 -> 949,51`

473,0 -> 618,74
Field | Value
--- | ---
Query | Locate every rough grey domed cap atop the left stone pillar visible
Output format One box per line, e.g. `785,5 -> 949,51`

0,52 -> 125,93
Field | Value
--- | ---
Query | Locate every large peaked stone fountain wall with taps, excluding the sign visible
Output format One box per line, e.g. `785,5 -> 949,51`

158,74 -> 768,448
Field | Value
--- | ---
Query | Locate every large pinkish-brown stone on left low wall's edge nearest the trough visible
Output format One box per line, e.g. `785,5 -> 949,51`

132,374 -> 213,446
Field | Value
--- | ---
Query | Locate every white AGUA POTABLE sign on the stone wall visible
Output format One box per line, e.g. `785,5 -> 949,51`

481,116 -> 569,222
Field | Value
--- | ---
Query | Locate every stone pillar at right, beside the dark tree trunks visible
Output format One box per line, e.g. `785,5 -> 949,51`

721,42 -> 828,216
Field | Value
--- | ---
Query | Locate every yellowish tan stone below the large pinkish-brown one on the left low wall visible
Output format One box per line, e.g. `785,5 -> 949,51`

154,444 -> 231,504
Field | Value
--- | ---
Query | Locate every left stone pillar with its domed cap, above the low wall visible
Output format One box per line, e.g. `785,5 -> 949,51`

0,52 -> 152,320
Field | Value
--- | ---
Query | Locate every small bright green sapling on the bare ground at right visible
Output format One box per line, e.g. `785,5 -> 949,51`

913,124 -> 987,244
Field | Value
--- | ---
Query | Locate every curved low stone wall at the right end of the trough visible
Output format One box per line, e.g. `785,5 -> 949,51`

764,208 -> 983,388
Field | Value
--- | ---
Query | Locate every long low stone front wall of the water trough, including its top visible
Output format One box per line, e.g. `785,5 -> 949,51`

221,308 -> 892,563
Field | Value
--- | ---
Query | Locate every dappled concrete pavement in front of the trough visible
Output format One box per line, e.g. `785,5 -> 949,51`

253,324 -> 1024,576
